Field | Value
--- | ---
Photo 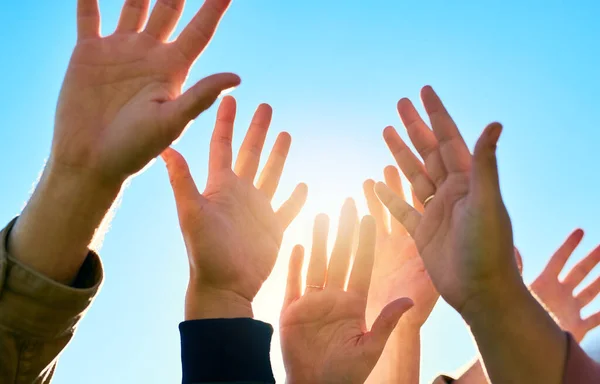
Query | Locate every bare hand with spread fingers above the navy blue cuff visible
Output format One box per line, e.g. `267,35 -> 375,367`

163,96 -> 307,320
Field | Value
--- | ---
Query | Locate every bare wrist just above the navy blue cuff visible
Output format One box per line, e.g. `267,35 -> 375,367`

185,282 -> 254,321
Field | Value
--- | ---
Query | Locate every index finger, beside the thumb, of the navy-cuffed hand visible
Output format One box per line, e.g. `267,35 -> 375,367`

208,96 -> 236,179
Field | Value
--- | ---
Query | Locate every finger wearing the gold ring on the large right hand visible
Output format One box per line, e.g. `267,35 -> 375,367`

383,127 -> 435,201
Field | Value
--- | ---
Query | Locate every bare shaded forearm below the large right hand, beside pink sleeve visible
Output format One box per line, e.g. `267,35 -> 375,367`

462,283 -> 567,384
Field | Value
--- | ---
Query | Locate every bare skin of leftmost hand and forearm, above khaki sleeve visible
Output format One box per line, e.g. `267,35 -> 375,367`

8,0 -> 240,284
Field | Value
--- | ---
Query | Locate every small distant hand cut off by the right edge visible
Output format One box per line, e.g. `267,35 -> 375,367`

530,229 -> 600,342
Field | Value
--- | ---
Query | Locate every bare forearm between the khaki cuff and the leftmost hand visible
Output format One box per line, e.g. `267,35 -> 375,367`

8,165 -> 121,285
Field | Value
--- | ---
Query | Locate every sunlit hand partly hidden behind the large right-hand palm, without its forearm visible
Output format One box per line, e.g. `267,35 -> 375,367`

363,166 -> 439,330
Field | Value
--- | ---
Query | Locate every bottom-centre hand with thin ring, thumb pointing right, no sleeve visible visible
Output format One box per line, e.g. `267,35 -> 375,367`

280,200 -> 412,383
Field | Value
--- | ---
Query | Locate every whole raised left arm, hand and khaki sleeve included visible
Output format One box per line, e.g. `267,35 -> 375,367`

0,0 -> 239,382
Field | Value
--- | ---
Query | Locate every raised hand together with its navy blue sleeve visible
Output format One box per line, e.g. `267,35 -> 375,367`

163,96 -> 307,384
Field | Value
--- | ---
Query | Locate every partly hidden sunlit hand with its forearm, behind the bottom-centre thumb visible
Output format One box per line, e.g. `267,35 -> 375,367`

363,171 -> 439,384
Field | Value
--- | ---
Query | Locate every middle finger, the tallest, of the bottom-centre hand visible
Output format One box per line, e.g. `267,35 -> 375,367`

326,199 -> 358,289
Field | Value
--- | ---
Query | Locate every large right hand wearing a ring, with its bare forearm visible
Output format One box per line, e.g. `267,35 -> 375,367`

376,87 -> 567,384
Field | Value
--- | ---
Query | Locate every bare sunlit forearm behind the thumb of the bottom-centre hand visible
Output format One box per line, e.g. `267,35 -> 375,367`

367,319 -> 421,384
